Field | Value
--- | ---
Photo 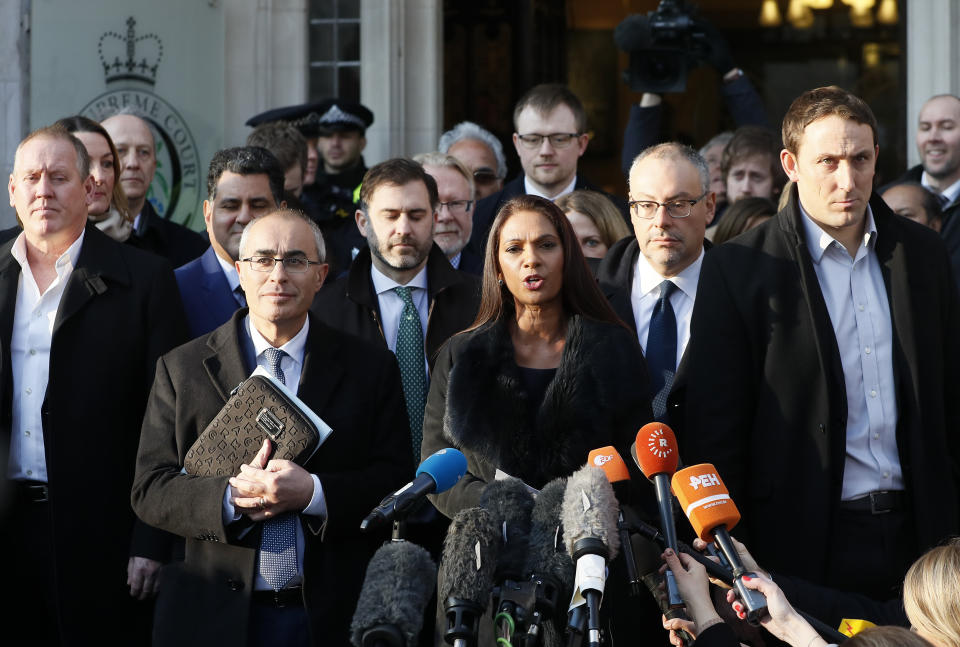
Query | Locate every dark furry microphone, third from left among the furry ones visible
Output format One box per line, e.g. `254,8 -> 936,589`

480,478 -> 536,641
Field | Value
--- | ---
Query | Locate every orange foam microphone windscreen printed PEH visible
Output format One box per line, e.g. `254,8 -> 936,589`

672,463 -> 740,542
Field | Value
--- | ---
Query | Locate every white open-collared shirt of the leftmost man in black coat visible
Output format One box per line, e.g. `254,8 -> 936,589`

7,231 -> 85,483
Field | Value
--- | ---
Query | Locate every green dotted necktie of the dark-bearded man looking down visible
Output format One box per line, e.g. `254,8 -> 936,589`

394,287 -> 427,464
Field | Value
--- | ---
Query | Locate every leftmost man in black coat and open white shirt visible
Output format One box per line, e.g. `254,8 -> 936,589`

0,128 -> 186,645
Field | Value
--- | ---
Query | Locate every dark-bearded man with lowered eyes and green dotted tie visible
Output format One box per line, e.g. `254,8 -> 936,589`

312,158 -> 480,462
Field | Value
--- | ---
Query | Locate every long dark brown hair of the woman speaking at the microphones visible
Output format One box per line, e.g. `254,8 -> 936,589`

468,195 -> 626,330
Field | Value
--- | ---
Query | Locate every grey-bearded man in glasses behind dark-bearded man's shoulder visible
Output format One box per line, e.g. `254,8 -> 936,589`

413,152 -> 483,276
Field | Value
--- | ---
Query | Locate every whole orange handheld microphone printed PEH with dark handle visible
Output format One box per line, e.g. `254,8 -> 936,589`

673,463 -> 767,625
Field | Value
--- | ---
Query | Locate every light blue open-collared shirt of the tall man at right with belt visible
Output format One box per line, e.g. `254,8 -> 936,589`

801,205 -> 904,501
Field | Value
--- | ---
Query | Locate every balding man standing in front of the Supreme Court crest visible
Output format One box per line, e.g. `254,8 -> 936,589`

103,114 -> 207,267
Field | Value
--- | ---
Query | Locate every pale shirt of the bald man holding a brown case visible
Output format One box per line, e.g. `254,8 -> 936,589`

223,315 -> 327,591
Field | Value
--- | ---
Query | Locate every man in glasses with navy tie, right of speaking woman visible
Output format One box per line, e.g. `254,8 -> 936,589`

597,143 -> 716,433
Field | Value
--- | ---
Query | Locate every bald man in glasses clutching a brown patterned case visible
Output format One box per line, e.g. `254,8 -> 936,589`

133,210 -> 413,646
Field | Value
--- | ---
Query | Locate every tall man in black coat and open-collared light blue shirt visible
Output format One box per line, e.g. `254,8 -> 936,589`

681,87 -> 960,599
